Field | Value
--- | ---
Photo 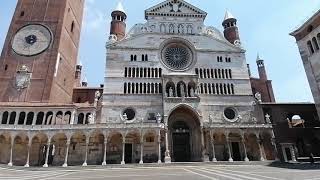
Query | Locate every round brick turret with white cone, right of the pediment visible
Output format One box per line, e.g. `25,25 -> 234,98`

222,11 -> 241,45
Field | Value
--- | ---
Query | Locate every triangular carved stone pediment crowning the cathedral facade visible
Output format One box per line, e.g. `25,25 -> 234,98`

145,0 -> 207,19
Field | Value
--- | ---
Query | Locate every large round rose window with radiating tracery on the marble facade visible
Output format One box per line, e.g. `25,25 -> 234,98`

162,43 -> 193,70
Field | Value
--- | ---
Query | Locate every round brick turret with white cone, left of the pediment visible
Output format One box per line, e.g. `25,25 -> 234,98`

110,2 -> 127,41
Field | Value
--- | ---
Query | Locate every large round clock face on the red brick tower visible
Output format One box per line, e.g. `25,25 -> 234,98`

12,24 -> 52,56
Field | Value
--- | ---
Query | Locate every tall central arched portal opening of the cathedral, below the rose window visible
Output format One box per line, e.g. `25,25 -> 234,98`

168,106 -> 201,162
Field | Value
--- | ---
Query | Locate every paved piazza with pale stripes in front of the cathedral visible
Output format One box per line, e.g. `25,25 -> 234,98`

0,164 -> 320,180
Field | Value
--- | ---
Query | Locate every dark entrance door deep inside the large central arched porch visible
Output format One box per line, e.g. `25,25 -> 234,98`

172,133 -> 190,162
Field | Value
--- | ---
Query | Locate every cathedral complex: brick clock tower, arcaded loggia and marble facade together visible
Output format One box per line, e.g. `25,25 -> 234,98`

0,0 -> 277,167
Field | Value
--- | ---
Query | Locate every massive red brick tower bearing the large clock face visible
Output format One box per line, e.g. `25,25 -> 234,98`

0,0 -> 84,103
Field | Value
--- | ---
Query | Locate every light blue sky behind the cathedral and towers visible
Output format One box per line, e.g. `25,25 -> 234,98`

0,0 -> 320,102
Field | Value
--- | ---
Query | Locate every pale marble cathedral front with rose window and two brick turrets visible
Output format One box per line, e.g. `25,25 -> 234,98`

101,0 -> 275,163
